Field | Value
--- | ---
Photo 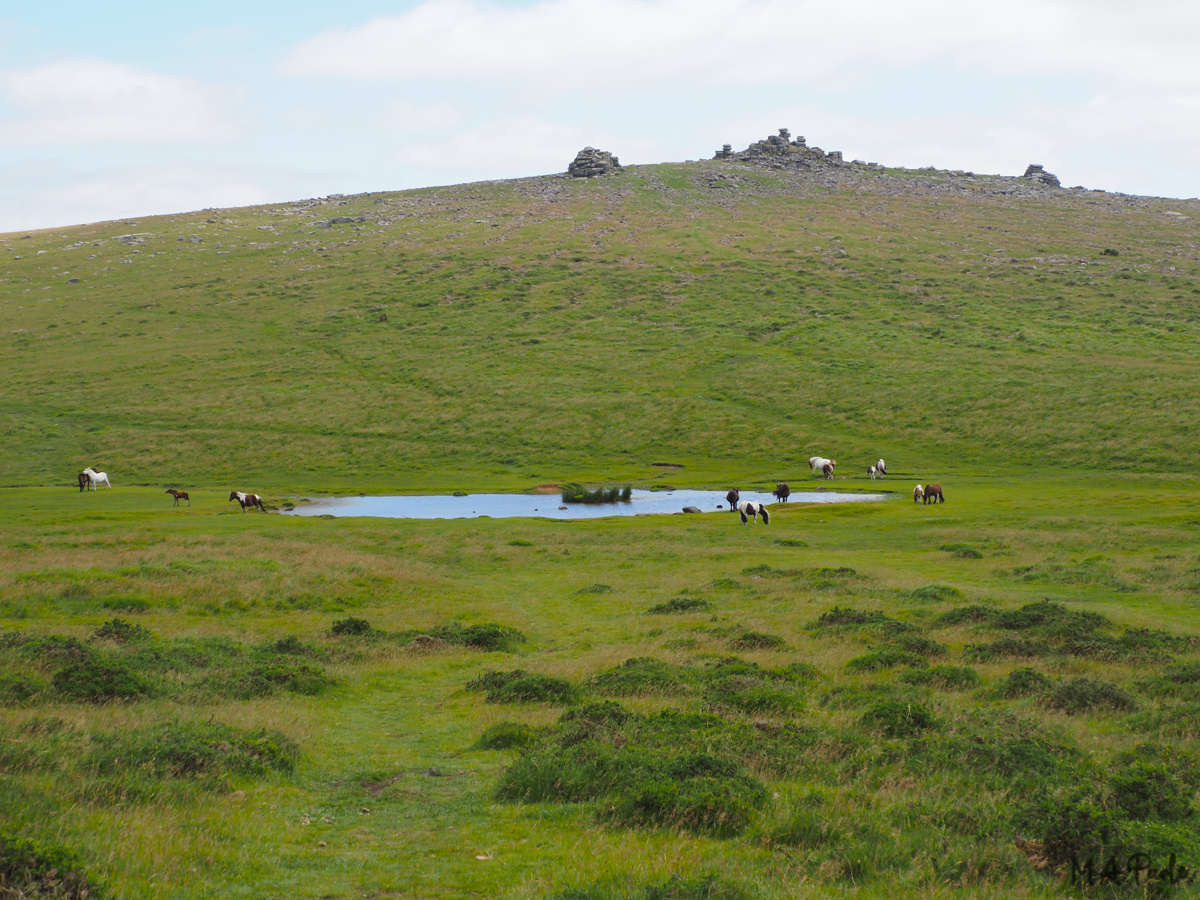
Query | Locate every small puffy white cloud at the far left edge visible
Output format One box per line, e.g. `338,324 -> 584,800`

0,59 -> 236,144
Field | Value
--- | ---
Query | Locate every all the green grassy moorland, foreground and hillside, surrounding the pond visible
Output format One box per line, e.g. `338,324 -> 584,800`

0,163 -> 1200,900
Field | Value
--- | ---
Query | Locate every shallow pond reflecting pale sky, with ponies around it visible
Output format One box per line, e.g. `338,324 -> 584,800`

284,491 -> 887,518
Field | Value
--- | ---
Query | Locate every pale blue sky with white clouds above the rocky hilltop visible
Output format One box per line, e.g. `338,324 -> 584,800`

0,0 -> 1200,232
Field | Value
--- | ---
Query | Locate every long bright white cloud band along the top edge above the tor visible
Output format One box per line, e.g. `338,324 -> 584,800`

282,0 -> 1200,96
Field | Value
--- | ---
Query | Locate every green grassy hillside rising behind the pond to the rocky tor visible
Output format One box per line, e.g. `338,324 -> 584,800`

0,161 -> 1200,490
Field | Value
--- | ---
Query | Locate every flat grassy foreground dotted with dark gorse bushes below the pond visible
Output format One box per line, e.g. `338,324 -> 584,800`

0,474 -> 1200,898
